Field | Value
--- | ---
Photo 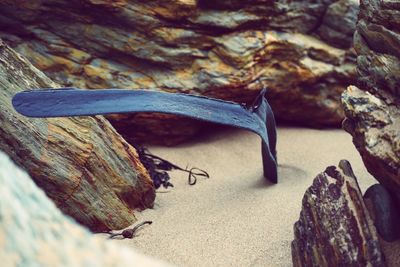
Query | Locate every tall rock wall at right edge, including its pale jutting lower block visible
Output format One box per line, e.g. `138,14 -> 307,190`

342,0 -> 400,203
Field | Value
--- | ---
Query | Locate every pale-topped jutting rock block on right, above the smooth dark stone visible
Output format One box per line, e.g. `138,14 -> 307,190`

342,86 -> 400,206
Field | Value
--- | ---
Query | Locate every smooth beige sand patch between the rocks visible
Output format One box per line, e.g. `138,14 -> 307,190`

111,128 -> 375,266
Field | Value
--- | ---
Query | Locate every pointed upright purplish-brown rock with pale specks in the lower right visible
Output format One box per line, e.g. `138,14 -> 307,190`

292,160 -> 385,266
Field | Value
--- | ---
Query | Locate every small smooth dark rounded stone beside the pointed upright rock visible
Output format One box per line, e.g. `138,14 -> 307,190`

364,184 -> 400,242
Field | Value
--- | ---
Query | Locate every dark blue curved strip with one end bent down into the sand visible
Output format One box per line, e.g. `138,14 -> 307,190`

13,88 -> 278,183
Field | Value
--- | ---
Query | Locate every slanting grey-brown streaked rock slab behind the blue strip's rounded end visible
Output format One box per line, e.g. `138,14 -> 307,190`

0,41 -> 155,231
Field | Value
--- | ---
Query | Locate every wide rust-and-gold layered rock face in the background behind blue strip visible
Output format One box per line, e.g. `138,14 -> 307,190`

0,0 -> 358,143
